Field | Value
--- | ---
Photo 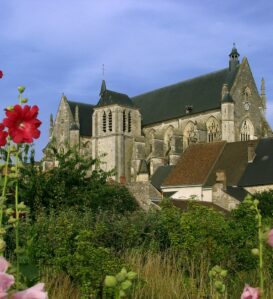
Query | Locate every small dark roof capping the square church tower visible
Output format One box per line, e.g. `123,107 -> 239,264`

97,89 -> 136,108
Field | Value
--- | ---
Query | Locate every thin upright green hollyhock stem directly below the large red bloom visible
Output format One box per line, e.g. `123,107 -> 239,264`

15,147 -> 19,288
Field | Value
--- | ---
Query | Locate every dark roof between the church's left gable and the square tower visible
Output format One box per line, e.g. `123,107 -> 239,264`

67,101 -> 94,137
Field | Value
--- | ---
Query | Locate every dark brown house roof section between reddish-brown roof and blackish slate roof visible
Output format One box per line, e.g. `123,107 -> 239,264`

205,140 -> 258,186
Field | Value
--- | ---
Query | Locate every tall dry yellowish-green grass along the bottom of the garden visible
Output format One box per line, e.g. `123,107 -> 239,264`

42,251 -> 273,299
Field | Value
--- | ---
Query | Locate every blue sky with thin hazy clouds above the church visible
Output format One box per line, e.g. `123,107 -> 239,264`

0,0 -> 273,160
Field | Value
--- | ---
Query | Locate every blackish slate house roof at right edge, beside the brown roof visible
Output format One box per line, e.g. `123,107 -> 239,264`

238,138 -> 273,187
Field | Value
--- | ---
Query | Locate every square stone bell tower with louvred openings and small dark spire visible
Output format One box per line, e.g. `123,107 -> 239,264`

92,80 -> 141,182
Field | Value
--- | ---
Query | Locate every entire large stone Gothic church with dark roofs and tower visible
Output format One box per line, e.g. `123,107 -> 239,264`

43,47 -> 272,183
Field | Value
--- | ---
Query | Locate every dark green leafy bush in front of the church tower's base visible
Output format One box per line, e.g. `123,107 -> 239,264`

20,149 -> 138,217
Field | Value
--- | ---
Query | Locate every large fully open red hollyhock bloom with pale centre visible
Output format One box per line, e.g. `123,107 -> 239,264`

3,105 -> 41,143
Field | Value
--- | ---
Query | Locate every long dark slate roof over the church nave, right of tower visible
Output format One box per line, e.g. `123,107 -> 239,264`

132,66 -> 239,125
